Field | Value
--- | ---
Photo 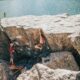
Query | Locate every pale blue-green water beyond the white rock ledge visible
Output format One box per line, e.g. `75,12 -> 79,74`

0,0 -> 80,17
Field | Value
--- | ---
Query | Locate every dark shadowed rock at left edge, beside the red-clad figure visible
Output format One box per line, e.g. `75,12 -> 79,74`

0,30 -> 9,61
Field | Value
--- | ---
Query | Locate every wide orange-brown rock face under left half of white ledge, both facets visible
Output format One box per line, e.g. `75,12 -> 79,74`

5,26 -> 40,45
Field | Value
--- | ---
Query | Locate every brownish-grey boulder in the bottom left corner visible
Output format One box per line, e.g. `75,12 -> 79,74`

0,60 -> 13,80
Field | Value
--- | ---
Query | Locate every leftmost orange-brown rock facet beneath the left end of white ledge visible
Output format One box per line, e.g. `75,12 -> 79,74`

5,26 -> 28,45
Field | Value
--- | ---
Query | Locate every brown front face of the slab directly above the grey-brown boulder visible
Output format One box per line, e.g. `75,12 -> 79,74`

45,33 -> 73,52
